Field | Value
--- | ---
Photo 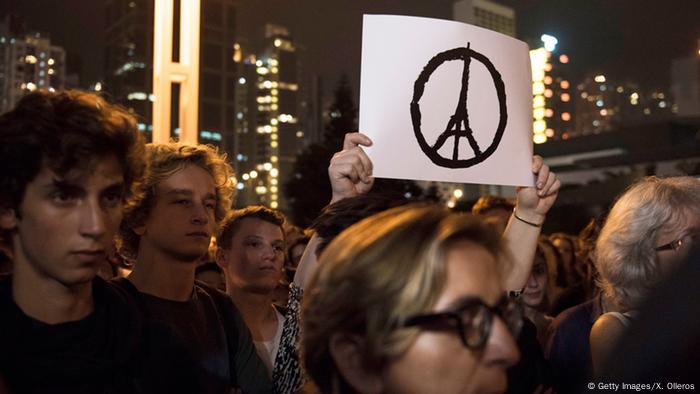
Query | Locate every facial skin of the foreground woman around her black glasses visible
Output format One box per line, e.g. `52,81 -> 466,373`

382,241 -> 519,394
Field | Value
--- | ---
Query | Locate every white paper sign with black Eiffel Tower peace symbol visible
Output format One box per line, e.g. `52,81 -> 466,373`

360,15 -> 534,186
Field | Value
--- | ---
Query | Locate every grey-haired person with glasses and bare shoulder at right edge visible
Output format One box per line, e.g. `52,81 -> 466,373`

590,177 -> 700,374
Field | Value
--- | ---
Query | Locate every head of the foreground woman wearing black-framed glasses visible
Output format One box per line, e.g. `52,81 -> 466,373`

302,205 -> 523,393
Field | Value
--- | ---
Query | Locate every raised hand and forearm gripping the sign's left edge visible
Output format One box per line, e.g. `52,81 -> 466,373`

294,133 -> 374,289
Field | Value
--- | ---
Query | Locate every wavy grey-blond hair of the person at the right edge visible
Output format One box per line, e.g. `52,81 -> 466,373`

594,176 -> 700,310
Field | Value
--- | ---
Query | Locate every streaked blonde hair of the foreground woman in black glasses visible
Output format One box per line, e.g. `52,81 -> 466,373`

302,205 -> 505,392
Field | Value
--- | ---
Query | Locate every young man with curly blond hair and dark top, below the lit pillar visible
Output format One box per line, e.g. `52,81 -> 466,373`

119,143 -> 272,393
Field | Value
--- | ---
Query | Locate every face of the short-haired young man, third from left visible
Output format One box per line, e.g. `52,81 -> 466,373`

217,218 -> 284,293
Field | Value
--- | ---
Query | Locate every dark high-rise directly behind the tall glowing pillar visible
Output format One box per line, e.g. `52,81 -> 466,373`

105,0 -> 237,154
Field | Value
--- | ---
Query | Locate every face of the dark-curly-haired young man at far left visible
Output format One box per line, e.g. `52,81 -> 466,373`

0,156 -> 124,286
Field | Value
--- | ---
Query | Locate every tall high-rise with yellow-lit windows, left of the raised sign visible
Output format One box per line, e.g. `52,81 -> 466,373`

236,24 -> 304,210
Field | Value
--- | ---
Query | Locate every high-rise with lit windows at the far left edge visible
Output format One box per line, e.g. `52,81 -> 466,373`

0,16 -> 66,113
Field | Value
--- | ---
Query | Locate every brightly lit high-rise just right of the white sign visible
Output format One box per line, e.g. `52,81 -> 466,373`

530,34 -> 574,144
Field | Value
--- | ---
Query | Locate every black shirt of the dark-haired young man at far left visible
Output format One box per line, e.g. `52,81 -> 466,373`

0,276 -> 194,394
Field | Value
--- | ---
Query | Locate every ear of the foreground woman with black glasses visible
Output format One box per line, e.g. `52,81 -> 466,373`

328,333 -> 384,394
